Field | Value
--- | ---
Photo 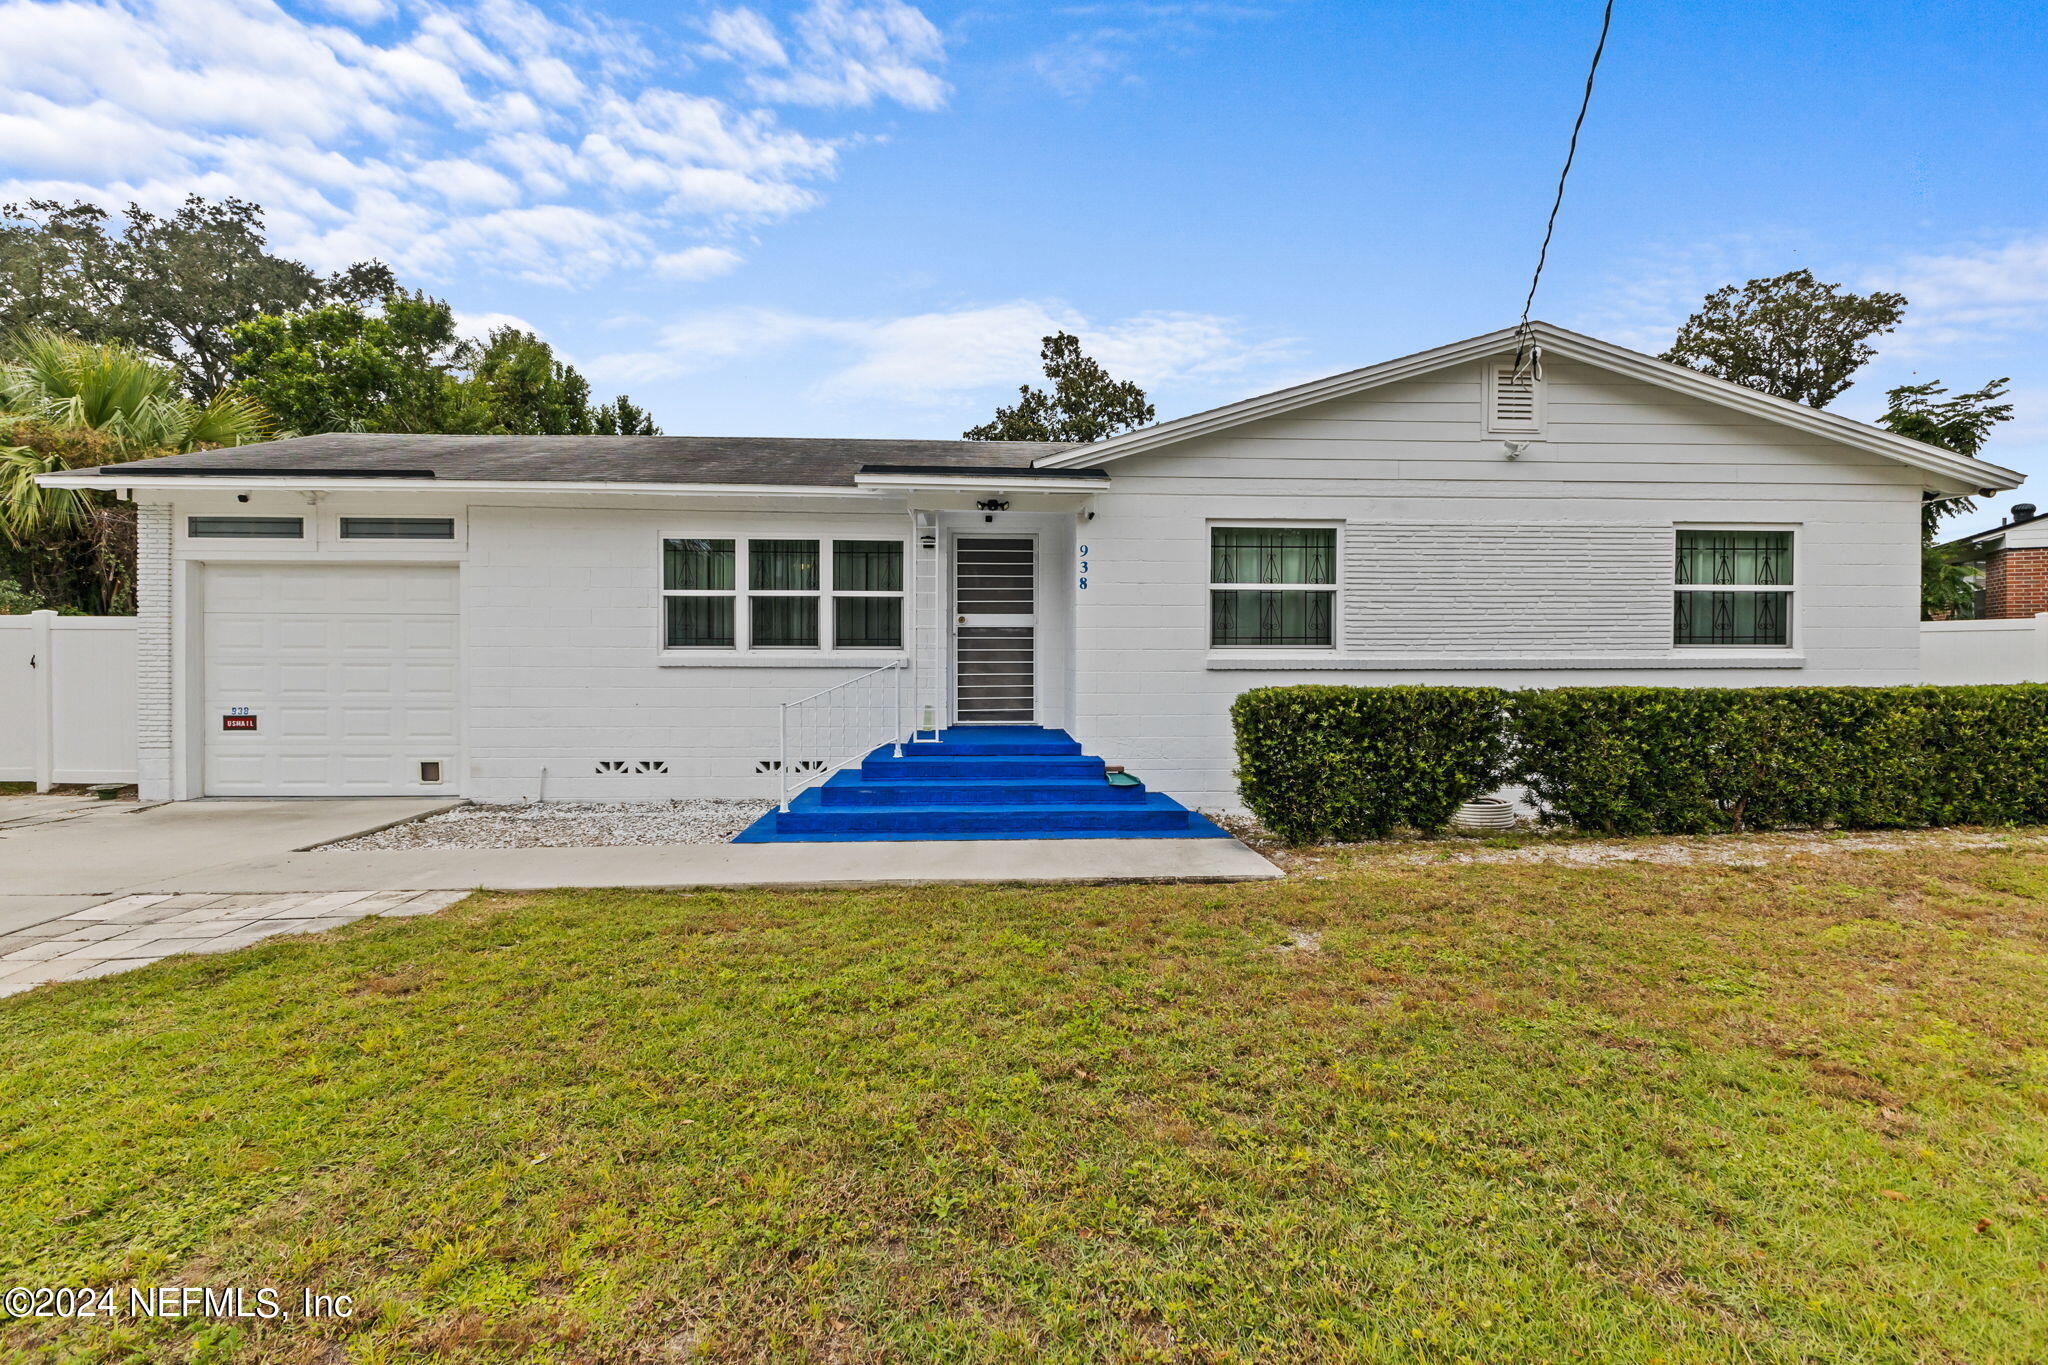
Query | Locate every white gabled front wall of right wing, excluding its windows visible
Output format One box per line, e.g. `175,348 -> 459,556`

1073,364 -> 1921,808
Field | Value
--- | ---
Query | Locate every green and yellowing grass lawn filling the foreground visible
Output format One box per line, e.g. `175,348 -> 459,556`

0,841 -> 2048,1365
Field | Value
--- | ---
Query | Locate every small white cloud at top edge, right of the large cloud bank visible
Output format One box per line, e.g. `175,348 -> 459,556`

705,0 -> 948,108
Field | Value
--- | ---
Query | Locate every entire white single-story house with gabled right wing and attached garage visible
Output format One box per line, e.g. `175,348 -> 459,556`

45,323 -> 2019,834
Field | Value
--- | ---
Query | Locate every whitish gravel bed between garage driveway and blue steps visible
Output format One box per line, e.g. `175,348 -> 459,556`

326,800 -> 772,851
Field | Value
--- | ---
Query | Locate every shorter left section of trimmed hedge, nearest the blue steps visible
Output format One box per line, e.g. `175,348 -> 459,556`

1231,686 -> 1507,843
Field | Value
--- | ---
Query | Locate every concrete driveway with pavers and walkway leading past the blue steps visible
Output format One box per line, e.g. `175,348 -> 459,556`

0,796 -> 1280,995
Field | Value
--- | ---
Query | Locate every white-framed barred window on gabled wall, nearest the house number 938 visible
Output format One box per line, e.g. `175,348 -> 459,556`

1208,526 -> 1337,649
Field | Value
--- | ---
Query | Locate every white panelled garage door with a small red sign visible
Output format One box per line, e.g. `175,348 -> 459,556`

201,565 -> 459,796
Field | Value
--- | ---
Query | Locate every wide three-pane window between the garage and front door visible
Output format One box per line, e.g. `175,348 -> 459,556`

662,538 -> 903,651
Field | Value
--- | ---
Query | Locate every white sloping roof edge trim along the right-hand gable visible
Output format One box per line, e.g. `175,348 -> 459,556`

1038,321 -> 2023,491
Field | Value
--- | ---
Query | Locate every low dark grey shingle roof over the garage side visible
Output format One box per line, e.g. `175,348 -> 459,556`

83,432 -> 1067,487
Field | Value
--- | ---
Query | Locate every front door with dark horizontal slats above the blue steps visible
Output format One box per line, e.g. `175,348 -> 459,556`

952,536 -> 1038,724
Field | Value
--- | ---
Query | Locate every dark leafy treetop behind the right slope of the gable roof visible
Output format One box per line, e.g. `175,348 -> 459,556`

1663,270 -> 1907,407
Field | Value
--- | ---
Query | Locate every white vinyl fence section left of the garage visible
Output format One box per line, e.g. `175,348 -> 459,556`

0,612 -> 135,792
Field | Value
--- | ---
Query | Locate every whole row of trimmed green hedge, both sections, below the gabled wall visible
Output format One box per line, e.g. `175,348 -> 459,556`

1231,684 -> 2048,843
